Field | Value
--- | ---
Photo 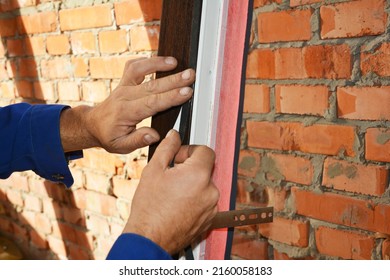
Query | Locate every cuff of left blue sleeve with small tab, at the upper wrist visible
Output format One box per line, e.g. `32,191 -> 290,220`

30,105 -> 82,187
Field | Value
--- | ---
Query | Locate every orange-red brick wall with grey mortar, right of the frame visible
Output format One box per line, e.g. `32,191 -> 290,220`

233,0 -> 390,259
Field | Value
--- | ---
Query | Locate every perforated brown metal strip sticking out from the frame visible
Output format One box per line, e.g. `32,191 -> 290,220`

211,207 -> 274,229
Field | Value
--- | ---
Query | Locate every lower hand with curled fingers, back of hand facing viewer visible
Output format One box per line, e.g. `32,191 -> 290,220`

124,130 -> 219,254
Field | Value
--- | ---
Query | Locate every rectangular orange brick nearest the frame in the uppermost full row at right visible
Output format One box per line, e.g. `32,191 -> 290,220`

257,9 -> 313,43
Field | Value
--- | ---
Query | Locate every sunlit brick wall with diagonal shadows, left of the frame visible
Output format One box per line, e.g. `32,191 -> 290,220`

0,0 -> 162,259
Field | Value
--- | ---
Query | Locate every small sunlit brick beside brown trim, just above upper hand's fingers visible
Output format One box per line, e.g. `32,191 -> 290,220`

130,26 -> 160,52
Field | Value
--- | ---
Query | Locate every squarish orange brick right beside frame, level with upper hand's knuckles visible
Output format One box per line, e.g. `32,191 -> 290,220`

244,84 -> 271,114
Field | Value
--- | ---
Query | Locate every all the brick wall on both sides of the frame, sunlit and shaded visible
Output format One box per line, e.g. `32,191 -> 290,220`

0,0 -> 390,259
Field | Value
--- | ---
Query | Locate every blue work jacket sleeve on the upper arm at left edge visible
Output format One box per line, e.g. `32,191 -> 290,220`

0,103 -> 82,187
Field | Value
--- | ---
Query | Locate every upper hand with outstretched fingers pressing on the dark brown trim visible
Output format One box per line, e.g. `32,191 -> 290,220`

60,57 -> 195,154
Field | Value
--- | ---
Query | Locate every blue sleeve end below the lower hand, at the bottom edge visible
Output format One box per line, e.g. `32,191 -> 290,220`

107,233 -> 172,260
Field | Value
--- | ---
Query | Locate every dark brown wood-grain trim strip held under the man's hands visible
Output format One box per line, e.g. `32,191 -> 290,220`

149,0 -> 202,160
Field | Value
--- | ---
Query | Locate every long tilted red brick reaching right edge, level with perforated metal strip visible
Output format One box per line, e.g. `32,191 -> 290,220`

291,187 -> 390,234
